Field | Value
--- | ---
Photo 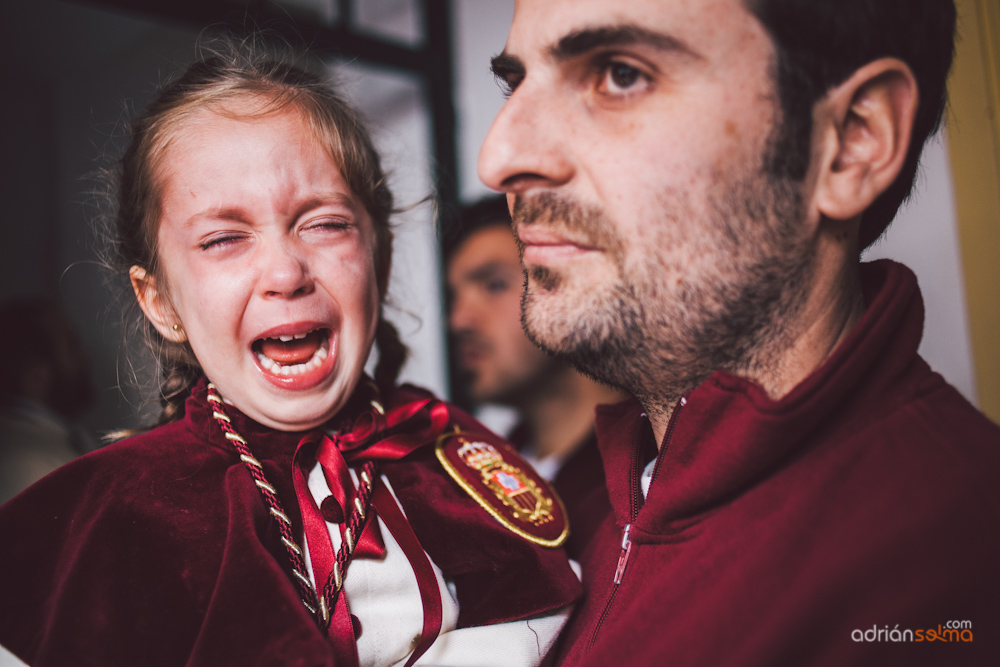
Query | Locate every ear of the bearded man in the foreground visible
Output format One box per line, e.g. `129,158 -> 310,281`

813,58 -> 918,220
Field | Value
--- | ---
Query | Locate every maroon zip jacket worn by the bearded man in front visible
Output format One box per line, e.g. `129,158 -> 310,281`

560,261 -> 1000,667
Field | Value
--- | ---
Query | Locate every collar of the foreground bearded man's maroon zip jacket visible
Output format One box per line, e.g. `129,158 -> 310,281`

596,260 -> 926,541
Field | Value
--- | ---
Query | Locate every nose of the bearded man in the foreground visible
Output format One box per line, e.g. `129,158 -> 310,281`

479,79 -> 573,194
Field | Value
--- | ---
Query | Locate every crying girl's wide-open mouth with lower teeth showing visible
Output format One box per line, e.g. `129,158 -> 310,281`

253,329 -> 332,388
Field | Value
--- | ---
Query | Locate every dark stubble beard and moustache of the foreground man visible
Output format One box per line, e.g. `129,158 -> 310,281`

514,144 -> 812,407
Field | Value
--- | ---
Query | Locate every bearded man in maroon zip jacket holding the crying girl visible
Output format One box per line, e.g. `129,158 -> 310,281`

479,0 -> 1000,666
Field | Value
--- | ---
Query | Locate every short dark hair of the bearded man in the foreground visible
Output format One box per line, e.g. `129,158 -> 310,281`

745,0 -> 955,248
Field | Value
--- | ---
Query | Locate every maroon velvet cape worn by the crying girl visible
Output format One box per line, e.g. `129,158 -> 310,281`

0,381 -> 580,667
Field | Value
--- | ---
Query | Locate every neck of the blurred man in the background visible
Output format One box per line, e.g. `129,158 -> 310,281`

518,368 -> 625,459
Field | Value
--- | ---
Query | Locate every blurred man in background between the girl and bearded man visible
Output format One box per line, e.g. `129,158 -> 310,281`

448,197 -> 624,557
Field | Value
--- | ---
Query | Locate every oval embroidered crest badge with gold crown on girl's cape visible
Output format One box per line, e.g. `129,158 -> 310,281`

435,433 -> 569,547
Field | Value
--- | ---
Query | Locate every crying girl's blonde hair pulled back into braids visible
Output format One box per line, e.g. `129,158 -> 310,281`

111,37 -> 406,424
